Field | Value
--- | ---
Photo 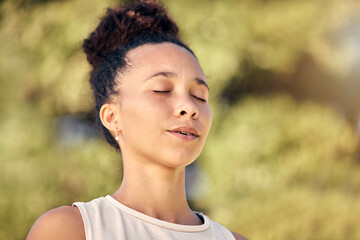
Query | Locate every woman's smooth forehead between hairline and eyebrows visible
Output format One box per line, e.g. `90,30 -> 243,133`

126,42 -> 205,78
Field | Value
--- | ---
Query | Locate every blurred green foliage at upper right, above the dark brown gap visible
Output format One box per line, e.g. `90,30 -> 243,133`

170,0 -> 360,97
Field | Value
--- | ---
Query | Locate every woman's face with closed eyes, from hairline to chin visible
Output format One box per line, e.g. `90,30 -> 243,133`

115,43 -> 212,167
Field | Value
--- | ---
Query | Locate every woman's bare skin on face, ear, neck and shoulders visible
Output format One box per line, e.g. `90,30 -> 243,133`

27,43 -> 245,240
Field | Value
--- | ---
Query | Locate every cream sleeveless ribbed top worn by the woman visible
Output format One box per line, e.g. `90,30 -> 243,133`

73,195 -> 235,240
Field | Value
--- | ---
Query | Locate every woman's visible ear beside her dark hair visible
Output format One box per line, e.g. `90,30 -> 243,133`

99,103 -> 121,132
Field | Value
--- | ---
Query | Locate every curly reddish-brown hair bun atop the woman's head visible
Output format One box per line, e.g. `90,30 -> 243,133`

82,0 -> 178,67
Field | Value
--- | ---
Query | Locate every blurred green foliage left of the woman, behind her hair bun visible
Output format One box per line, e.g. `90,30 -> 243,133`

0,1 -> 121,239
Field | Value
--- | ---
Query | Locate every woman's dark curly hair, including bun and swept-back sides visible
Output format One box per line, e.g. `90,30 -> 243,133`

82,0 -> 195,150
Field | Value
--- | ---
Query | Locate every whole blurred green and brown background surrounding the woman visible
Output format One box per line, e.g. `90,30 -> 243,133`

0,0 -> 360,240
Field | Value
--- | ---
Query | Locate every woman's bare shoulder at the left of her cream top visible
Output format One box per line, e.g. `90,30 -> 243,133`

26,206 -> 85,240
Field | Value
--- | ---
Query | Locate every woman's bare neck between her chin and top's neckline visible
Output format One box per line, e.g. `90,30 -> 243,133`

112,156 -> 202,225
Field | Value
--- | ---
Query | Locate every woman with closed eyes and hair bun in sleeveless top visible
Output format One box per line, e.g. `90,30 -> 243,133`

28,1 -> 245,240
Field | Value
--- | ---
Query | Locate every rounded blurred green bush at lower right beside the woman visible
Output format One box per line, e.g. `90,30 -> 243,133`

201,96 -> 360,239
